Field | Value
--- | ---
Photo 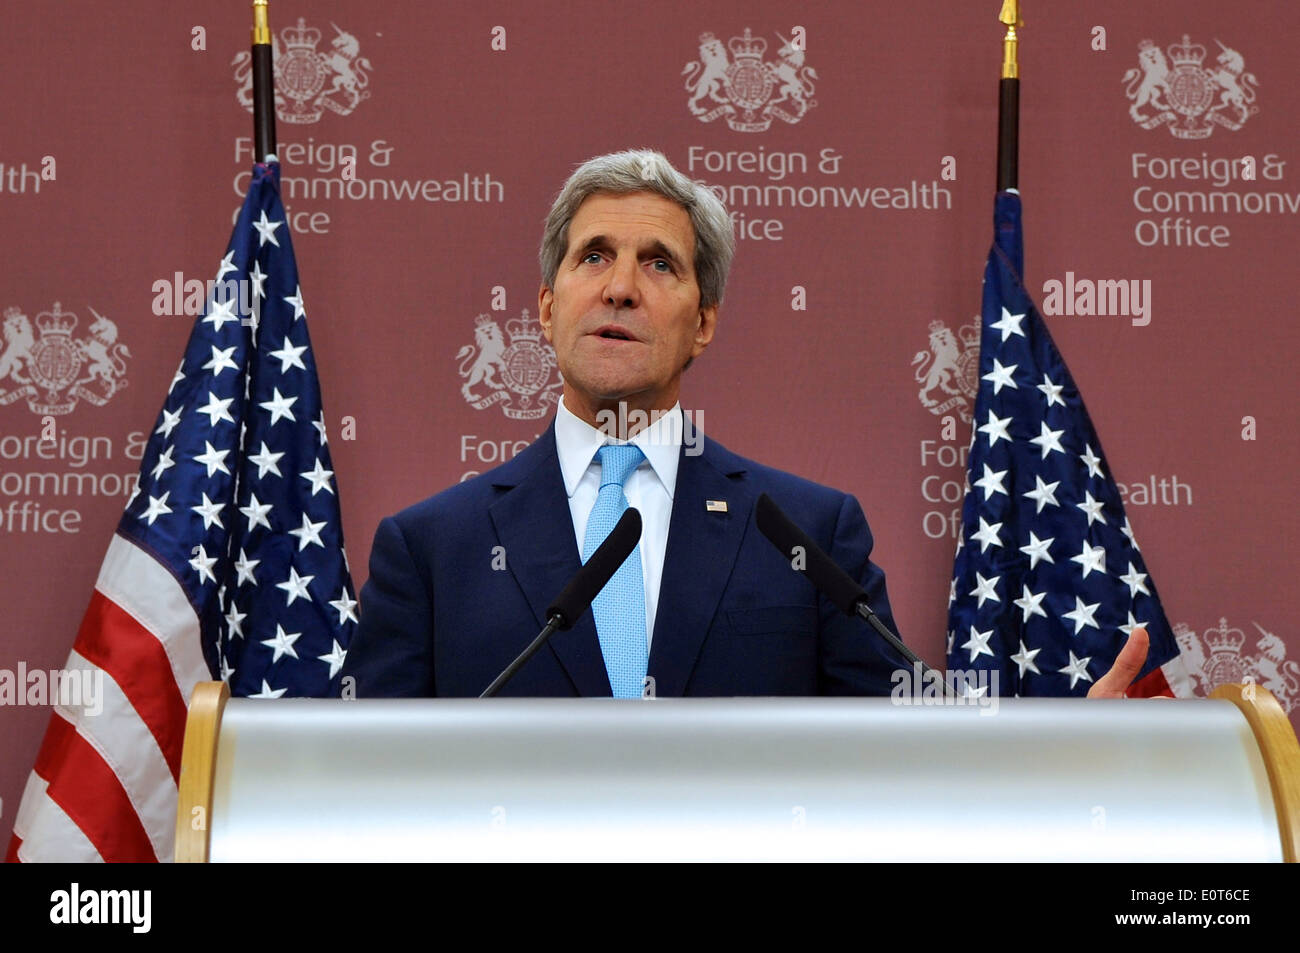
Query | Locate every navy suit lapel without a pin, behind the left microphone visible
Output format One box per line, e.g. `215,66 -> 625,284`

488,424 -> 611,696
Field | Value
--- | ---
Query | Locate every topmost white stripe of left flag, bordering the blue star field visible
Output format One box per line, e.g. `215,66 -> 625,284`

95,533 -> 212,686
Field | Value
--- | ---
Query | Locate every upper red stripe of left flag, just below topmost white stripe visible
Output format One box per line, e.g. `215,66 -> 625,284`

73,590 -> 186,784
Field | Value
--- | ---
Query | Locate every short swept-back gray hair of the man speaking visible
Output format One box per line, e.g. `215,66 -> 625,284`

537,150 -> 736,308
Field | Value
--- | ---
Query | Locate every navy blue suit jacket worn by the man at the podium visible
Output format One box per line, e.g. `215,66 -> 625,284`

343,424 -> 907,698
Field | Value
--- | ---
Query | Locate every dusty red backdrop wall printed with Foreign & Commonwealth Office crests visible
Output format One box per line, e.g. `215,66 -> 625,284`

0,0 -> 1300,840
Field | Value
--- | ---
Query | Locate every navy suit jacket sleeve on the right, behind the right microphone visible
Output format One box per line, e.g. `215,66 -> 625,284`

818,495 -> 911,696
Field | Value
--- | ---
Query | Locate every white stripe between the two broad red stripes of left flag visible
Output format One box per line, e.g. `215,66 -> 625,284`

55,651 -> 177,861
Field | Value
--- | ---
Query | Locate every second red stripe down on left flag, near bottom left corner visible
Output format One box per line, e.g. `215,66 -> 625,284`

35,712 -> 159,863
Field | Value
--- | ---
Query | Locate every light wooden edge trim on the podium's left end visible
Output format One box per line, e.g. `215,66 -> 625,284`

176,681 -> 230,863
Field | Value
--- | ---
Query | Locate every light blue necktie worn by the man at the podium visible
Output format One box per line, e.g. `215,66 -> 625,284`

582,443 -> 649,698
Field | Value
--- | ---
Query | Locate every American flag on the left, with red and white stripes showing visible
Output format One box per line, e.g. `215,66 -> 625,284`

7,163 -> 358,861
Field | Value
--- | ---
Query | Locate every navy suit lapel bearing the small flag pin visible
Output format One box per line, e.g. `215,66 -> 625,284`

649,429 -> 754,697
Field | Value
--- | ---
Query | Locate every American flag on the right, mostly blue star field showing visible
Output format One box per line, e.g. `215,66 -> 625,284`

948,191 -> 1191,697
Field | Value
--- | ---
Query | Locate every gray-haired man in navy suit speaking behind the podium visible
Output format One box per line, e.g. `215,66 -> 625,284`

343,151 -> 1141,697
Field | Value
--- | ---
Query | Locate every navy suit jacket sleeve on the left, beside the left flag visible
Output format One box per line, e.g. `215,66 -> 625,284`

343,516 -> 434,698
